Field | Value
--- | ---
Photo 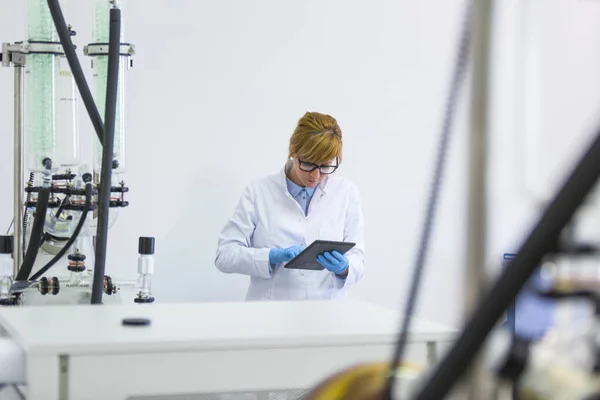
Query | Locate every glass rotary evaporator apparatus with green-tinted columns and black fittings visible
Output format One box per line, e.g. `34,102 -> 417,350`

0,0 -> 154,305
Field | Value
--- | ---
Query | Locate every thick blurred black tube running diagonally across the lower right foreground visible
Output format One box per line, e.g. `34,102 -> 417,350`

415,123 -> 600,400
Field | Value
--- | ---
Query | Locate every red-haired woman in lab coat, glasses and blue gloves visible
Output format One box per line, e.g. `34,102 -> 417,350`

215,112 -> 365,300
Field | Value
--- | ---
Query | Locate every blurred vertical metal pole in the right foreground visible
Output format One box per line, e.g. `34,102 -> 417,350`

464,0 -> 492,400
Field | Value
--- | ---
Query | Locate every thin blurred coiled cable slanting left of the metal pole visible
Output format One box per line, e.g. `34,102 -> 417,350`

385,0 -> 471,399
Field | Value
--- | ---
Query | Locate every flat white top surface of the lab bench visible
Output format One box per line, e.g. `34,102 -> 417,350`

0,301 -> 457,355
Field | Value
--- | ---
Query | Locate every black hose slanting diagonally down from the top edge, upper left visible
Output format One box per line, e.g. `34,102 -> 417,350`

48,0 -> 104,145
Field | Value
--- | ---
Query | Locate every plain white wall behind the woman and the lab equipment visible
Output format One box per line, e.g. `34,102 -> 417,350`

0,0 -> 600,323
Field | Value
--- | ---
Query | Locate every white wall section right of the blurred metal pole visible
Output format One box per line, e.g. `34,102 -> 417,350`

490,0 -> 600,260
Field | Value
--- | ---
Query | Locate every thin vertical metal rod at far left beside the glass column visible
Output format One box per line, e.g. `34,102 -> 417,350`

13,64 -> 24,278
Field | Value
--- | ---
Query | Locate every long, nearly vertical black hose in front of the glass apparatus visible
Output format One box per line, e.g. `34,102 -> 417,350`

91,8 -> 121,304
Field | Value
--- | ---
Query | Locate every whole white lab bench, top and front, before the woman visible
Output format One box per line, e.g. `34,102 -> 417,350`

0,300 -> 457,400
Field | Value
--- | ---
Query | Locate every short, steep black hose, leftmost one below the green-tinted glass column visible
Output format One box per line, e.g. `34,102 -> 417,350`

15,160 -> 52,281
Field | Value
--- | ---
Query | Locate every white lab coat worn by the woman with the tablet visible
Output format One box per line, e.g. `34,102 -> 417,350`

215,164 -> 365,300
